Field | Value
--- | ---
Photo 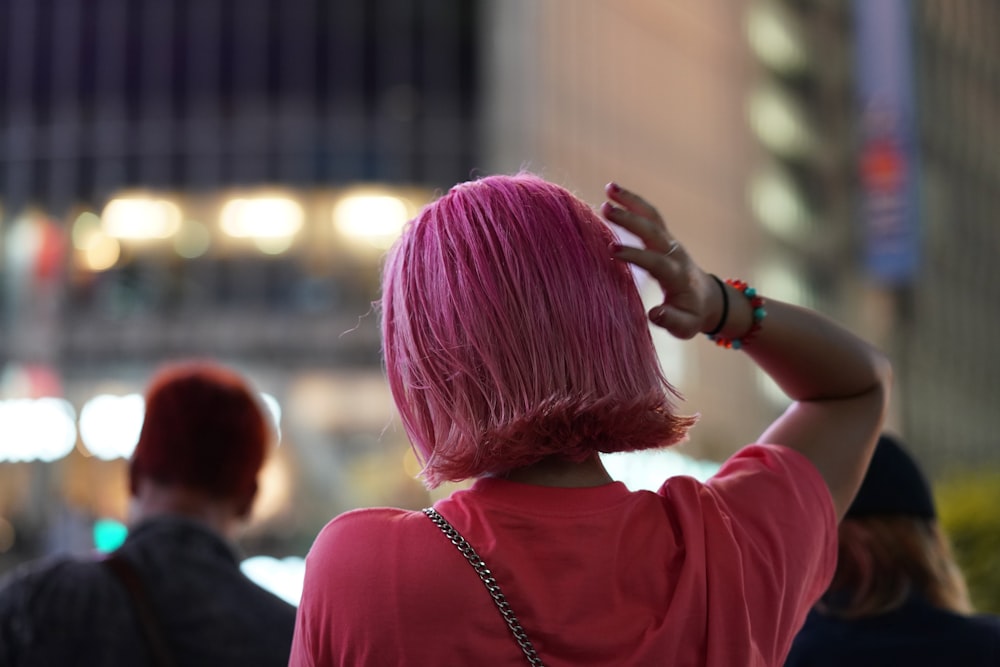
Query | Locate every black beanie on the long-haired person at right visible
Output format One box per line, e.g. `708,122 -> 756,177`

847,435 -> 936,519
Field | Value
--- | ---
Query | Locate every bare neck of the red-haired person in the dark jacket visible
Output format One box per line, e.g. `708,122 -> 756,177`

129,480 -> 243,539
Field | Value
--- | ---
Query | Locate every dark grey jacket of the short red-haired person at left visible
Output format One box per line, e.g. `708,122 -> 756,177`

0,517 -> 295,667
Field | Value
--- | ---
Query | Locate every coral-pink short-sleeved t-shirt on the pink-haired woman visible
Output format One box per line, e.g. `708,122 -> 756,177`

289,445 -> 837,667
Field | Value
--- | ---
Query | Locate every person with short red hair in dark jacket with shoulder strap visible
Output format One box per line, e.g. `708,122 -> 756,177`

0,363 -> 295,667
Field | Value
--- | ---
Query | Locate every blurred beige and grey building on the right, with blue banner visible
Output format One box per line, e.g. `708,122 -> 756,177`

486,0 -> 1000,476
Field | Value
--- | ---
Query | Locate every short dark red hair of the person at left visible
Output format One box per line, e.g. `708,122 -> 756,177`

130,362 -> 274,499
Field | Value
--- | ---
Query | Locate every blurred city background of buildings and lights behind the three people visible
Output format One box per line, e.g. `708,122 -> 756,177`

0,0 -> 1000,611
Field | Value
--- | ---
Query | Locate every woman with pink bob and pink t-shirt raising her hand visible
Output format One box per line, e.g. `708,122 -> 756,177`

290,174 -> 891,667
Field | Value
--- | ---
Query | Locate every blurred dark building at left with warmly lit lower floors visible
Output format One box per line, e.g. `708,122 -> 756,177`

0,0 -> 480,569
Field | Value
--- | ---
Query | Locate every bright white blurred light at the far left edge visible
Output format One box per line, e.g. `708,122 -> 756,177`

0,398 -> 76,461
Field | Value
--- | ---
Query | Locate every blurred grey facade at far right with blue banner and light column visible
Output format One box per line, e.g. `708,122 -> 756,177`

747,0 -> 1000,477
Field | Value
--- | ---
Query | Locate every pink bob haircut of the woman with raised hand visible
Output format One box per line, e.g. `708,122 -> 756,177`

382,173 -> 696,488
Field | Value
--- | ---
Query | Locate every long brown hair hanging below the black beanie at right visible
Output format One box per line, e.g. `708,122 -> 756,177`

817,515 -> 972,618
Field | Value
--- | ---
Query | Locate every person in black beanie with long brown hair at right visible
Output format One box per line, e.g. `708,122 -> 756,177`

785,434 -> 1000,667
